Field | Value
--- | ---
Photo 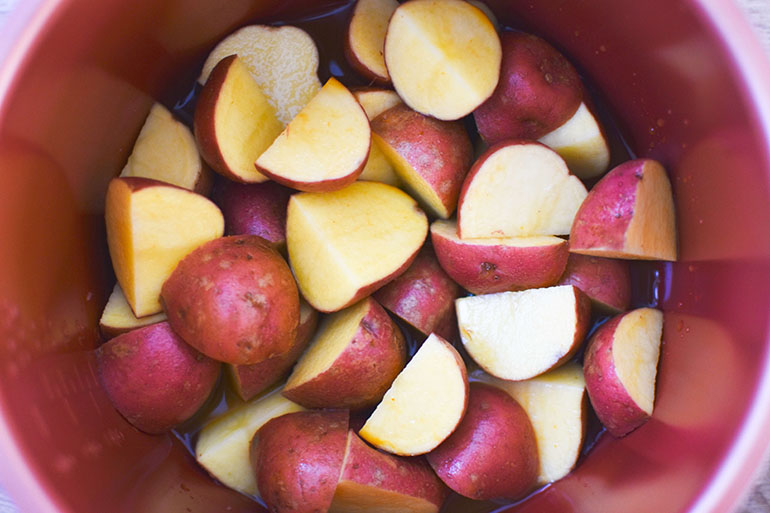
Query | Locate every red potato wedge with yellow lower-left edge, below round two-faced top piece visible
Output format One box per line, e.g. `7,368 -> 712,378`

372,104 -> 473,219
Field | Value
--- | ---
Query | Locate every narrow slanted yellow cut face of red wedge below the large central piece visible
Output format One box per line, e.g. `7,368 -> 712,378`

286,301 -> 369,389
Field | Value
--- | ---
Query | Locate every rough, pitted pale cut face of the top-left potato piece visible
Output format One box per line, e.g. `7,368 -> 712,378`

198,25 -> 321,125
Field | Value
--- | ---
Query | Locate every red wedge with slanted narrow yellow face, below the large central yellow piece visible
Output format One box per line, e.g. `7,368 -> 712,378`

283,298 -> 406,409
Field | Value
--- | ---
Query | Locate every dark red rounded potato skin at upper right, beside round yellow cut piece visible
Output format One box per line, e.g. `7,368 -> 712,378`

473,31 -> 583,145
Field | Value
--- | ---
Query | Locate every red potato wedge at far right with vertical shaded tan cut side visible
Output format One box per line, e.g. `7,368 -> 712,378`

570,159 -> 676,261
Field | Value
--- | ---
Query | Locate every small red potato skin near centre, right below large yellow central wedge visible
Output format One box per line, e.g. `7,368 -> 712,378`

374,246 -> 460,340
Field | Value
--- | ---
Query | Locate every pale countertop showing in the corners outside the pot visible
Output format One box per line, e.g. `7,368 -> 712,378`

0,0 -> 770,513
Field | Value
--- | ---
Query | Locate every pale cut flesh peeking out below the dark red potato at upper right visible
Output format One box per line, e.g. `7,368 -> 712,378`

540,103 -> 610,180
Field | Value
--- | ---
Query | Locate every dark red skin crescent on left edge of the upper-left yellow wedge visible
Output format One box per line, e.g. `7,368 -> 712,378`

193,55 -> 250,182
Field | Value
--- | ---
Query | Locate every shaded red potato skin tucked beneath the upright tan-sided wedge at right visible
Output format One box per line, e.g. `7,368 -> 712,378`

558,253 -> 631,313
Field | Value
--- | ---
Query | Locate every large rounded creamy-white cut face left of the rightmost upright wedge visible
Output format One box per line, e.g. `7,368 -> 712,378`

458,144 -> 588,239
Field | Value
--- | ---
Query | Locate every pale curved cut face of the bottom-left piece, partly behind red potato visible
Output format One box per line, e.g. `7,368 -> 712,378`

195,388 -> 304,496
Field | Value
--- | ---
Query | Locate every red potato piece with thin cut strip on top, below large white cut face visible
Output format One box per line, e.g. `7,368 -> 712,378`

430,220 -> 569,294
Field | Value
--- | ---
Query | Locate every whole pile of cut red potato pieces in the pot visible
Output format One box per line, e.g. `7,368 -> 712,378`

97,0 -> 676,512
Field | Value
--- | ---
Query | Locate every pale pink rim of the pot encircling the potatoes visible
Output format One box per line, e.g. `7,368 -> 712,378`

0,0 -> 770,513
